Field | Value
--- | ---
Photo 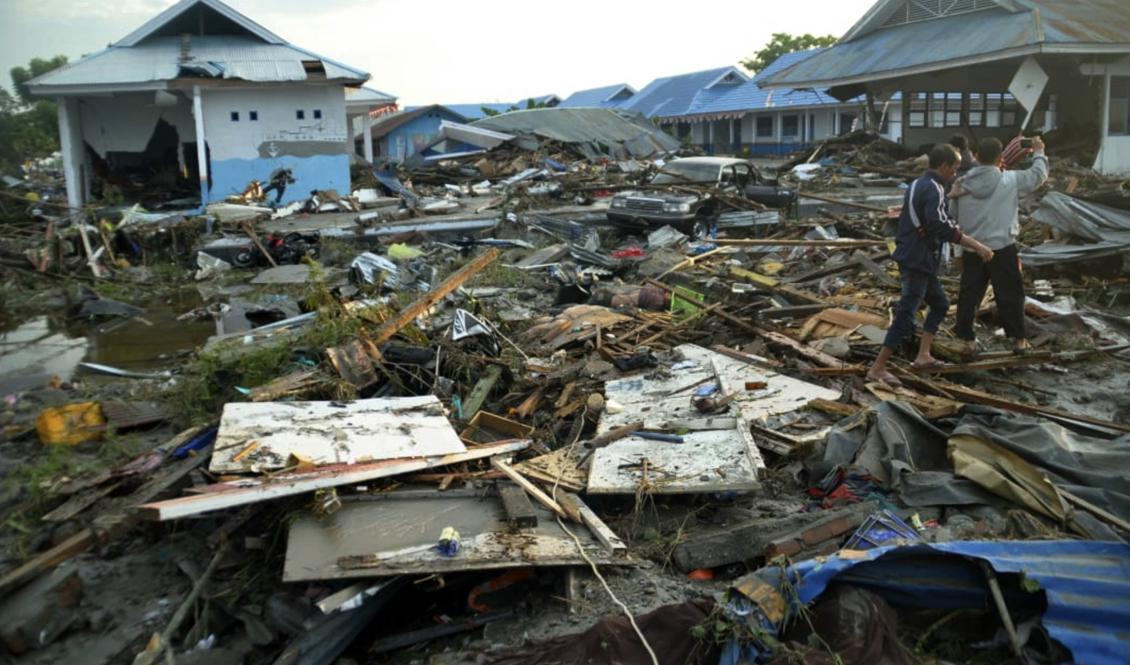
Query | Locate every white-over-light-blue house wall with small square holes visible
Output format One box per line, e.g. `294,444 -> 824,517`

203,85 -> 349,204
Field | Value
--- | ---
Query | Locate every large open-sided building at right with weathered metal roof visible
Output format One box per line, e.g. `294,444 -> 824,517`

763,0 -> 1130,173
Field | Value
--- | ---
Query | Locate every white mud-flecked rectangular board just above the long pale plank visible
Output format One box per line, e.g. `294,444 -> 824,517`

209,395 -> 466,473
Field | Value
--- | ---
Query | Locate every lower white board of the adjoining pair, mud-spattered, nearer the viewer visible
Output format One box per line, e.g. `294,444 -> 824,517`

589,429 -> 758,494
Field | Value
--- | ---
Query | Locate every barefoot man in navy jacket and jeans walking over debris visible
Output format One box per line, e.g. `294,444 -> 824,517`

867,144 -> 992,386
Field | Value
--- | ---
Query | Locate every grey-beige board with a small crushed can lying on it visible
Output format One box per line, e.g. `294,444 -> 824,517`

283,492 -> 624,581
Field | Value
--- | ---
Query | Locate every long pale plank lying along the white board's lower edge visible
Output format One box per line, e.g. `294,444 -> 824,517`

141,441 -> 530,520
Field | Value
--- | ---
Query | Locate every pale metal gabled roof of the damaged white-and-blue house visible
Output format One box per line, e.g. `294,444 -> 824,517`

28,0 -> 368,94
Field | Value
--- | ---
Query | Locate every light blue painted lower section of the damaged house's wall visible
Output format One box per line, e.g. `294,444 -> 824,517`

207,152 -> 351,204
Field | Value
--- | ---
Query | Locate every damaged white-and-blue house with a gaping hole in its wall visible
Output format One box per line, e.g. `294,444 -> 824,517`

29,0 -> 379,208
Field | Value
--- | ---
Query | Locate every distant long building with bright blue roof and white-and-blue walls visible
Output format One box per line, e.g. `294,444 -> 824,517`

617,50 -> 897,154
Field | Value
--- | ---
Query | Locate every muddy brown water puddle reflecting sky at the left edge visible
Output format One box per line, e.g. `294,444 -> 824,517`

0,290 -> 216,395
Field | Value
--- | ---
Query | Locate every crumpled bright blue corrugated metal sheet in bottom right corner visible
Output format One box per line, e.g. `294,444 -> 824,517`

757,541 -> 1130,665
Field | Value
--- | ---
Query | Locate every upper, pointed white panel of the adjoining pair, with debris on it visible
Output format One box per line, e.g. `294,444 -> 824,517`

597,344 -> 840,434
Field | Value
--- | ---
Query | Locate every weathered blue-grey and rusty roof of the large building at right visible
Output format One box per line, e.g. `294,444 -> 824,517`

762,0 -> 1130,88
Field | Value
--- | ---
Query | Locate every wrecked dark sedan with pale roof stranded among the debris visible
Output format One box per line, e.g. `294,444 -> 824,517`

608,157 -> 797,238
